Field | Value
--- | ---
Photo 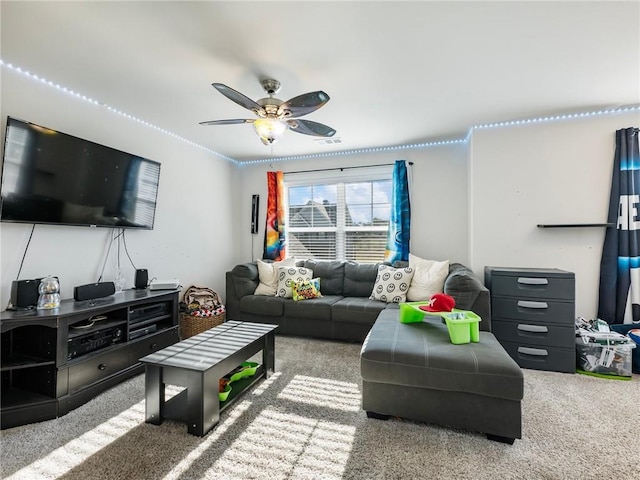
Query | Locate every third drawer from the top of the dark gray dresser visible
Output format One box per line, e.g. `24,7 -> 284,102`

491,320 -> 576,348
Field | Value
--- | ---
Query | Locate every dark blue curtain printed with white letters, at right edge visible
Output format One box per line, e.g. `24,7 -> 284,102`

598,128 -> 640,324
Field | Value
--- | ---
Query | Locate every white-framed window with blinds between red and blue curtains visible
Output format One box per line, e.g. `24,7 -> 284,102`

285,167 -> 392,262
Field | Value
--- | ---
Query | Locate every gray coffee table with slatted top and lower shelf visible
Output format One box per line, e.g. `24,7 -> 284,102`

140,321 -> 278,436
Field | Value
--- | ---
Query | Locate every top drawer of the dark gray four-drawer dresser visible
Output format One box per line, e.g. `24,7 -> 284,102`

491,272 -> 576,300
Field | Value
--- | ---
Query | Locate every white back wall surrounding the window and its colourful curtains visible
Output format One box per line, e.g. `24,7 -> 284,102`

236,144 -> 468,263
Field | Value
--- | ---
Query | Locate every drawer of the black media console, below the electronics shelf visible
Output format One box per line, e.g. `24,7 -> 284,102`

69,348 -> 131,393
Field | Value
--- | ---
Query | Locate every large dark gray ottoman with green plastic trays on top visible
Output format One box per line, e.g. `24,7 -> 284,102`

360,309 -> 523,443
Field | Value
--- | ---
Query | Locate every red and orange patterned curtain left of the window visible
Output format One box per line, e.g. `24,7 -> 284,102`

262,171 -> 286,261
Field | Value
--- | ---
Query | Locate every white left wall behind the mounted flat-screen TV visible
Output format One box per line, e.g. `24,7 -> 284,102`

0,69 -> 237,308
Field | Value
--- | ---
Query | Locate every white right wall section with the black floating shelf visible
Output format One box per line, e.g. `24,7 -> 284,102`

469,112 -> 640,318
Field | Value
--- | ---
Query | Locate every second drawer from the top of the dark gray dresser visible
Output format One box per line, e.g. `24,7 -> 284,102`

491,296 -> 576,326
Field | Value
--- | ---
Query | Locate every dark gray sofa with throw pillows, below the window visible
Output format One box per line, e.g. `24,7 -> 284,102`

225,260 -> 491,342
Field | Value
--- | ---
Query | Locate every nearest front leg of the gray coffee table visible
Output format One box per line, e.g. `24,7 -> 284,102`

187,369 -> 220,437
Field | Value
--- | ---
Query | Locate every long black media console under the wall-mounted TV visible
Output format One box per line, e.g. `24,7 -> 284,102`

0,289 -> 179,429
